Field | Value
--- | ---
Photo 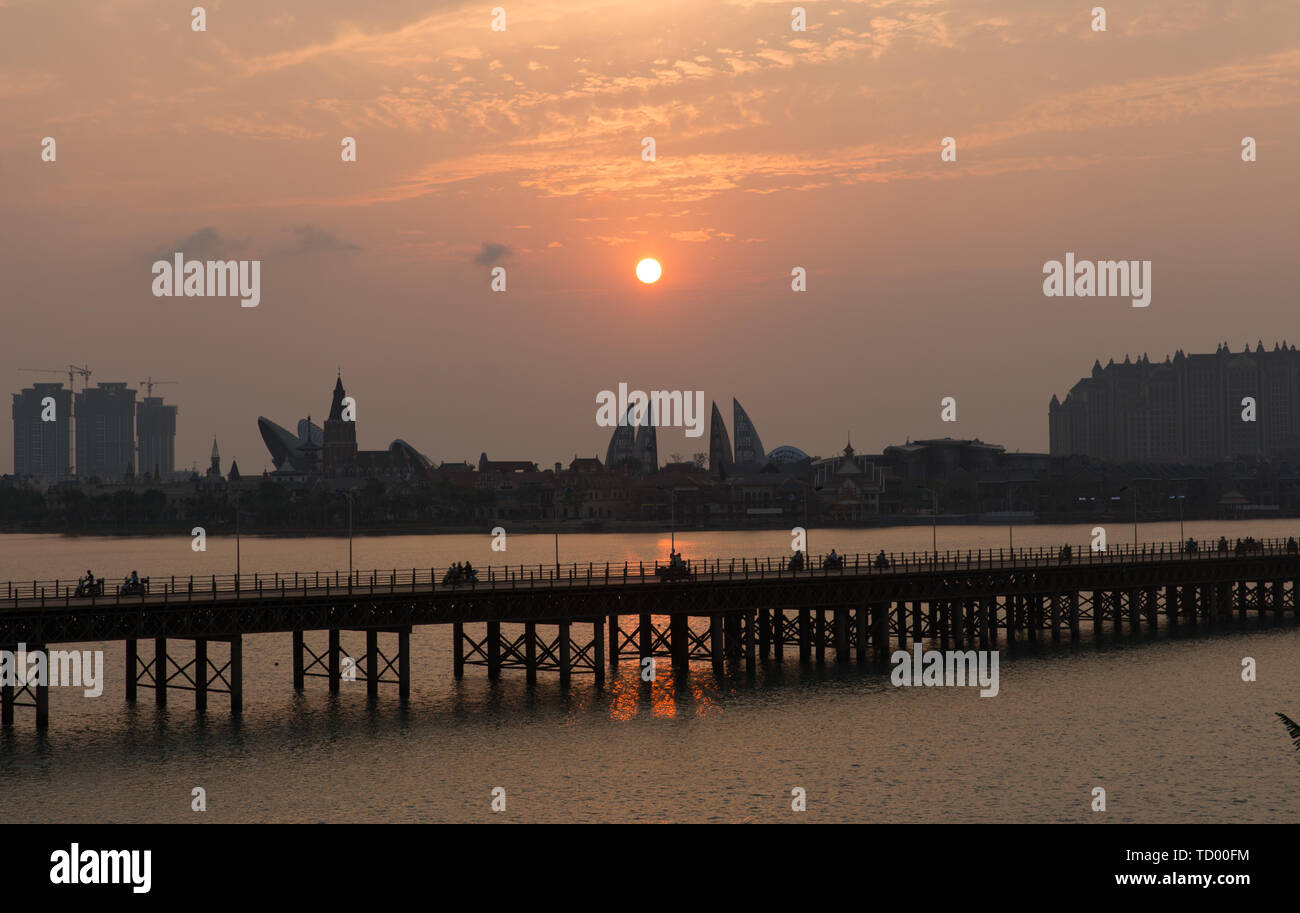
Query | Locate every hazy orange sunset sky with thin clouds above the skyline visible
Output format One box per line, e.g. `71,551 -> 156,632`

0,0 -> 1300,472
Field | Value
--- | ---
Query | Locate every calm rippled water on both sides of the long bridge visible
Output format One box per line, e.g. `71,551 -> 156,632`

0,522 -> 1300,822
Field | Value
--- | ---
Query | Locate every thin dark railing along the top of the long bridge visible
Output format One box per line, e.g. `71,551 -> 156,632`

4,537 -> 1300,607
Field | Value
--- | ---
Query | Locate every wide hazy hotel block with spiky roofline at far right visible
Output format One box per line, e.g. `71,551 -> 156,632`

1048,342 -> 1300,463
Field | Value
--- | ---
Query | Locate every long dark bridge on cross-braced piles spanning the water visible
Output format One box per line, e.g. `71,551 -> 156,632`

0,540 -> 1300,728
